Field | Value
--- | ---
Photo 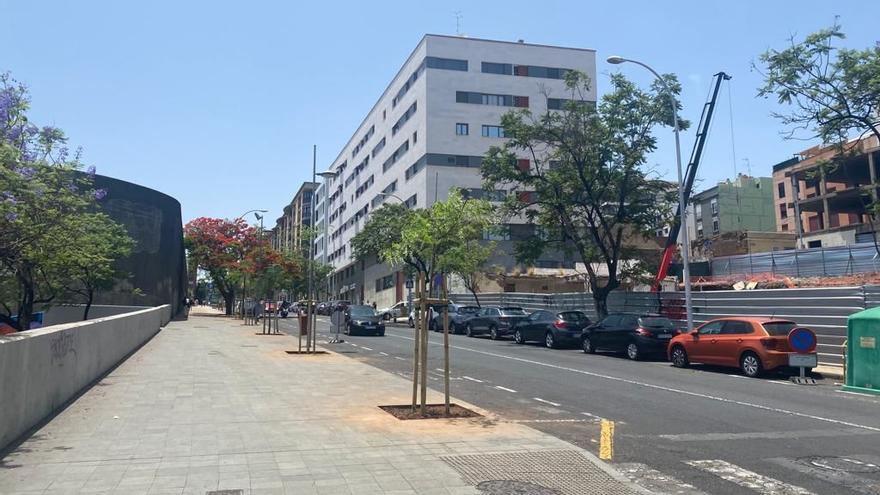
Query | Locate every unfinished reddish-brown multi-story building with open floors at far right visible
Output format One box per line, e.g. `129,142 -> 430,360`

773,136 -> 880,248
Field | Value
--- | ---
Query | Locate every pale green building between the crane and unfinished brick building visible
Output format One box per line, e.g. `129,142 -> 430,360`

687,174 -> 794,258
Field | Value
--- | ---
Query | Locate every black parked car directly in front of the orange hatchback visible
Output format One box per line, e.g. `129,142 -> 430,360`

581,313 -> 679,360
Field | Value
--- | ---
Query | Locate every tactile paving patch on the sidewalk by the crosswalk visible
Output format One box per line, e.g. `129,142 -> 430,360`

442,450 -> 635,495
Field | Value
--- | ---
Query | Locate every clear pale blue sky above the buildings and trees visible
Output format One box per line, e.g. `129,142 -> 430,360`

0,0 -> 880,221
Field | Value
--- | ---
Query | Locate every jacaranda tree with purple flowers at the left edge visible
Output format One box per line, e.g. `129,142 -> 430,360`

0,73 -> 131,330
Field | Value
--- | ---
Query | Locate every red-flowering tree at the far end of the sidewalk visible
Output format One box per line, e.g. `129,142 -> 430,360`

183,217 -> 260,315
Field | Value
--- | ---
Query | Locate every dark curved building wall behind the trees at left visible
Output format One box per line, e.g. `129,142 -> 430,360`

94,175 -> 187,314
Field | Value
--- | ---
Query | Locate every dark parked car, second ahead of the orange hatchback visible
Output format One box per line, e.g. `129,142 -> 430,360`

513,310 -> 590,349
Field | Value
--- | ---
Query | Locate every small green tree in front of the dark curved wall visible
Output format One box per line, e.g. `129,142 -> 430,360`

56,213 -> 134,320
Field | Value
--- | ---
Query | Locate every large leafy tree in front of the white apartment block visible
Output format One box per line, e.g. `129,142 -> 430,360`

481,72 -> 688,315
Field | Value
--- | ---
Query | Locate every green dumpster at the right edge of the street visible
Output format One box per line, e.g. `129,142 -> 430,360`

843,307 -> 880,395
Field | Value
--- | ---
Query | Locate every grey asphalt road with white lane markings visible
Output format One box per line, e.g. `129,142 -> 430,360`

282,317 -> 880,495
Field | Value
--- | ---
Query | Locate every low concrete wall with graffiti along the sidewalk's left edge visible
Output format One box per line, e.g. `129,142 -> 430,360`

0,304 -> 171,450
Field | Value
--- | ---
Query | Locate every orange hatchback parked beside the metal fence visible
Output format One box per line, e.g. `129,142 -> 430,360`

667,317 -> 809,377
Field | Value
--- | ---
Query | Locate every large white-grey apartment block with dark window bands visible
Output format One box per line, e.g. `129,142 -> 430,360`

315,35 -> 596,306
